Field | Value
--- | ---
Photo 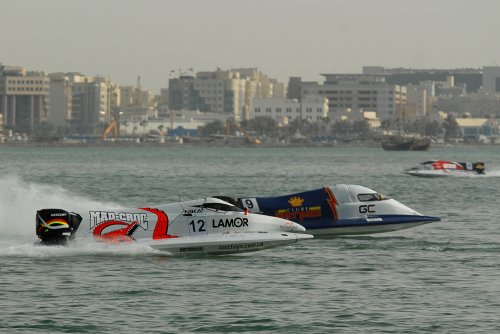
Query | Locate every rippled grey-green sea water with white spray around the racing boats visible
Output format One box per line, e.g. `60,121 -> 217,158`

0,147 -> 500,333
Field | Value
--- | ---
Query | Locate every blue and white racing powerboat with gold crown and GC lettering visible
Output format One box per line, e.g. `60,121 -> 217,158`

220,184 -> 441,236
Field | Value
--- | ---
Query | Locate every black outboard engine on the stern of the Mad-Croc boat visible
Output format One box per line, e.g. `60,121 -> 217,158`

36,209 -> 82,245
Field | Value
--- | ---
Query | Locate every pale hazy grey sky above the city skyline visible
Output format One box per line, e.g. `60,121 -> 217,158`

0,0 -> 500,93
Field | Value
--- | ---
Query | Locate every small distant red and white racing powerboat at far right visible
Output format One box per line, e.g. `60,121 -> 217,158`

406,160 -> 485,177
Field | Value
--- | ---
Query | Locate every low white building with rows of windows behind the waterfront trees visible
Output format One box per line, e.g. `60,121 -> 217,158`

254,96 -> 328,125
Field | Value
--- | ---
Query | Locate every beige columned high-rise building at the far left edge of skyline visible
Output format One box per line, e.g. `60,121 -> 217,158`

0,64 -> 49,134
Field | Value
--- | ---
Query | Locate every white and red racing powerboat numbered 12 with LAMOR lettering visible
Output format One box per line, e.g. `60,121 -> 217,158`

36,198 -> 312,255
